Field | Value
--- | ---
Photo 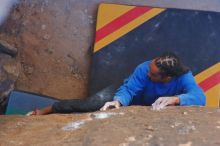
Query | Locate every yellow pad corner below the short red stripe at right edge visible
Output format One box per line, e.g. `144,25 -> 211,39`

205,84 -> 220,107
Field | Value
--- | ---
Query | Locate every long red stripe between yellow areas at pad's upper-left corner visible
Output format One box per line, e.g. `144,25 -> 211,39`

95,7 -> 151,42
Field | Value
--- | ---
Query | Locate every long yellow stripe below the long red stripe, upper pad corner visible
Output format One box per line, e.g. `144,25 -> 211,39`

94,8 -> 165,52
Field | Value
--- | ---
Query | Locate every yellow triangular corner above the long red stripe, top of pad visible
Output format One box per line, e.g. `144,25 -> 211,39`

96,4 -> 135,30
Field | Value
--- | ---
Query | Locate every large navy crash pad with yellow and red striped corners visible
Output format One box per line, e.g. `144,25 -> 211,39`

89,3 -> 220,107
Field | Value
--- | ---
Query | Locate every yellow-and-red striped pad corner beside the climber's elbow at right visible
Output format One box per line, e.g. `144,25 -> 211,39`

195,63 -> 220,107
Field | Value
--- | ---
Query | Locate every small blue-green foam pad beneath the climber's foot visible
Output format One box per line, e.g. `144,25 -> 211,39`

5,91 -> 58,115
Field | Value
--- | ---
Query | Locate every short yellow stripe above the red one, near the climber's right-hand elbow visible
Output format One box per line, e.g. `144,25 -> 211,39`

195,62 -> 220,84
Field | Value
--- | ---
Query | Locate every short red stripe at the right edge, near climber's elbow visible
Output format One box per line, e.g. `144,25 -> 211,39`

199,71 -> 220,92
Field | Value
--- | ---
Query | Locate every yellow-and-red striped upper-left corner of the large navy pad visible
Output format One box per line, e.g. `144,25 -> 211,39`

94,4 -> 165,52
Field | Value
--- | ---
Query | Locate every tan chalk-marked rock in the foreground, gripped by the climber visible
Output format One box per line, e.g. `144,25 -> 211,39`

0,106 -> 220,146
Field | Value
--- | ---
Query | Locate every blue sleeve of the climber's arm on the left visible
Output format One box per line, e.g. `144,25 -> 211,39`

114,65 -> 147,106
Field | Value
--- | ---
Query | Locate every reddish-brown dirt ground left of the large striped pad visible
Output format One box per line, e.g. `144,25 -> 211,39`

0,0 -> 91,99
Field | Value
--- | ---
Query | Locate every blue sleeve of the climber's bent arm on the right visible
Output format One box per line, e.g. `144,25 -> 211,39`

178,72 -> 206,106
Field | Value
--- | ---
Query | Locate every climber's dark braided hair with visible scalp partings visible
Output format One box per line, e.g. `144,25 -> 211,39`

155,52 -> 189,77
